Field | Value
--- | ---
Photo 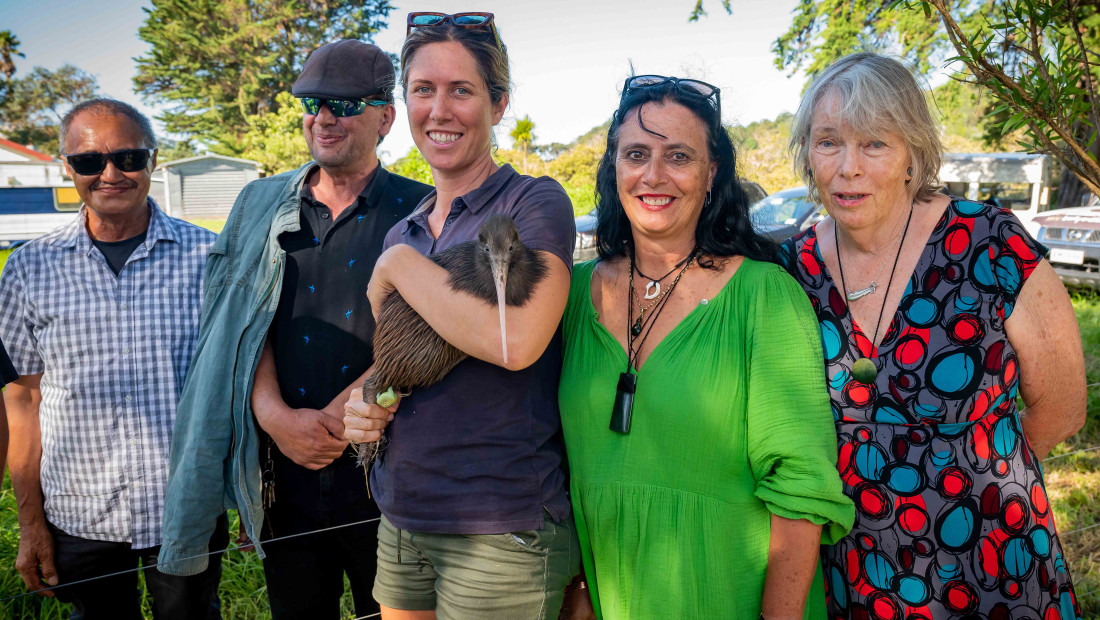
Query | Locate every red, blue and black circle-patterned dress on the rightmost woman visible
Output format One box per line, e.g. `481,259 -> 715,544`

781,200 -> 1080,620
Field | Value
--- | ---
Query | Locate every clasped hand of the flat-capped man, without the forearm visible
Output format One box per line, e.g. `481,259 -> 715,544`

255,409 -> 348,469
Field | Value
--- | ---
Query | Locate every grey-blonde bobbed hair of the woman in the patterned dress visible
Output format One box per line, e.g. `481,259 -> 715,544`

788,52 -> 944,202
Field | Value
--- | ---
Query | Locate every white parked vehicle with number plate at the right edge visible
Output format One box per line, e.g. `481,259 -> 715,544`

1034,206 -> 1100,289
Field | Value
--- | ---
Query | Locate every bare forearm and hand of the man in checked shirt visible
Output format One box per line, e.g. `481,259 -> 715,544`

3,374 -> 57,597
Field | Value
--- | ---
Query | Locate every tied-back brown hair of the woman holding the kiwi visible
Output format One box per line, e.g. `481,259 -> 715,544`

402,22 -> 512,104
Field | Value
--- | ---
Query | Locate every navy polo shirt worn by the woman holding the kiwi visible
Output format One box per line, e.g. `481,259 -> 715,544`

371,165 -> 575,534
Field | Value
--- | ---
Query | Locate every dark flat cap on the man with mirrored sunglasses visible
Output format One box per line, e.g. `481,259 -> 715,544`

290,38 -> 396,101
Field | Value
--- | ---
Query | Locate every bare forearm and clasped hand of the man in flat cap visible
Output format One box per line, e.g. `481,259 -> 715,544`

252,342 -> 348,469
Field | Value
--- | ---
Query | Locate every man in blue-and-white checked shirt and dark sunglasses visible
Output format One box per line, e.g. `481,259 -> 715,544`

0,99 -> 228,620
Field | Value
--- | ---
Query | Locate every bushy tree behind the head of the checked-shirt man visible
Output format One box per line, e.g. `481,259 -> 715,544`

0,65 -> 99,153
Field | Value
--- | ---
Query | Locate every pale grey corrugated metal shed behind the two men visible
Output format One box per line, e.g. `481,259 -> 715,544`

160,155 -> 260,220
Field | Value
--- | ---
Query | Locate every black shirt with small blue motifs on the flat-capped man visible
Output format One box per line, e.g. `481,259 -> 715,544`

268,166 -> 431,507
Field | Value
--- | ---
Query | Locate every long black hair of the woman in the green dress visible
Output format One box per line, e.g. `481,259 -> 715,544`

596,82 -> 776,268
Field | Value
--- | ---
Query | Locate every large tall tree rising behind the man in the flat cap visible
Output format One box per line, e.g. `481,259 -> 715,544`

134,0 -> 393,155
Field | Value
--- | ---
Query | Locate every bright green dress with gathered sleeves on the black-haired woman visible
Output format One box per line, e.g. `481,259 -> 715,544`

559,258 -> 854,620
